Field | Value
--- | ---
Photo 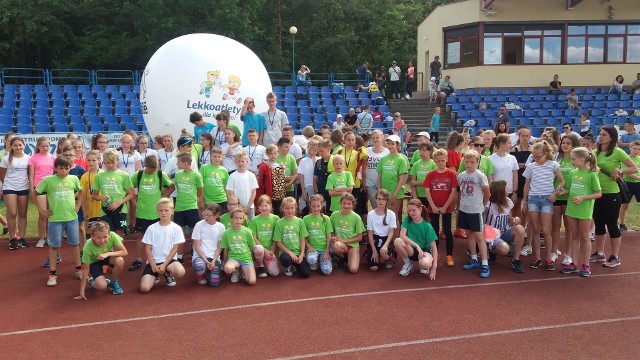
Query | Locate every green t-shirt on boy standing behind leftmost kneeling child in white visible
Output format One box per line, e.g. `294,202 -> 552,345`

131,171 -> 173,220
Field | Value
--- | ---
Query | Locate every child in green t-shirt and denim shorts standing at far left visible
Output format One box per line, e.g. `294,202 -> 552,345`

31,156 -> 82,286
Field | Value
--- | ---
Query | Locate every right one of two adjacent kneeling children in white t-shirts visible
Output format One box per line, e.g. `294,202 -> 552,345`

191,204 -> 225,286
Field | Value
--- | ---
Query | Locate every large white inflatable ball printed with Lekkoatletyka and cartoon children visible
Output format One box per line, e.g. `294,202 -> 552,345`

140,34 -> 271,139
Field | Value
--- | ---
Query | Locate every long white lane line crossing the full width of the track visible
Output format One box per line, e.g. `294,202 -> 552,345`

0,271 -> 640,337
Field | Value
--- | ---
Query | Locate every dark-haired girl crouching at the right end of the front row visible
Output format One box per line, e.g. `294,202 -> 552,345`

485,180 -> 525,273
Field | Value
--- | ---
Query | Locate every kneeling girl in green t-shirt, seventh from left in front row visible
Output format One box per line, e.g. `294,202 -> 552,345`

302,194 -> 333,275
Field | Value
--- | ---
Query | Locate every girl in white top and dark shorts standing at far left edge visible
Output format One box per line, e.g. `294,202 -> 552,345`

0,136 -> 30,250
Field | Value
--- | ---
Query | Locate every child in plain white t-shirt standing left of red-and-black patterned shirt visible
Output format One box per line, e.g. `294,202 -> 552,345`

226,151 -> 258,220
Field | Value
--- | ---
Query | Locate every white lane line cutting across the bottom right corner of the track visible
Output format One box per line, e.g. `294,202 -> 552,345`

273,316 -> 640,360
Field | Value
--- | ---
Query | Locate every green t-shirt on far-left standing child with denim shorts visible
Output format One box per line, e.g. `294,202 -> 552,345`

36,174 -> 82,222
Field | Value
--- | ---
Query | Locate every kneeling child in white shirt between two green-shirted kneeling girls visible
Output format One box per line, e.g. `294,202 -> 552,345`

364,189 -> 397,271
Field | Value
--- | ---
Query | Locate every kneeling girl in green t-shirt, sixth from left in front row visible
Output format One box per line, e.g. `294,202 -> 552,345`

273,196 -> 311,279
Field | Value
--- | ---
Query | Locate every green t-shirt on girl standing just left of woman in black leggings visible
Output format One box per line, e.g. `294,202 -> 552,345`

565,169 -> 601,220
